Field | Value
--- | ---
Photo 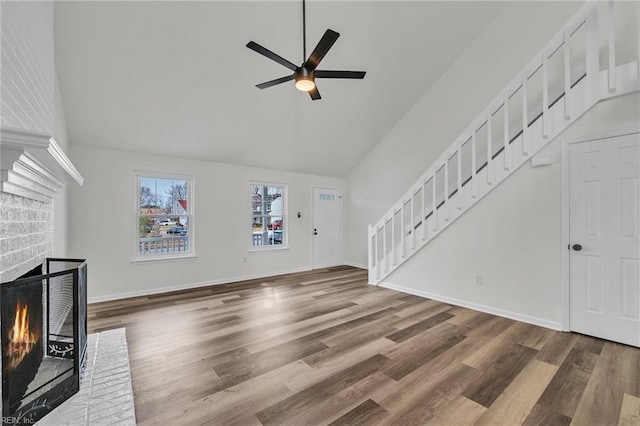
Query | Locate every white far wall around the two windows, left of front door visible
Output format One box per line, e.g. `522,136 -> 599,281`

69,145 -> 345,301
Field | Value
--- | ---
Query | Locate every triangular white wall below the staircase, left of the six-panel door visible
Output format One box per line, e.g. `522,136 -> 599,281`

385,140 -> 561,328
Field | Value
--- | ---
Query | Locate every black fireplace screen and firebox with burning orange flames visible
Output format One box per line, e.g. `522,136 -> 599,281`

0,258 -> 87,424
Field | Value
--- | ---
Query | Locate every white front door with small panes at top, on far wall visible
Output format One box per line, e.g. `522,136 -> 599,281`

313,188 -> 342,269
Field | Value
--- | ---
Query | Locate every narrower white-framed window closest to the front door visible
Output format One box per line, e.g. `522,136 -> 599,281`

251,182 -> 287,248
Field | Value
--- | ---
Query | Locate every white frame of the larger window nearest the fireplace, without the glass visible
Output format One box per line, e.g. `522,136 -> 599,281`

131,170 -> 197,263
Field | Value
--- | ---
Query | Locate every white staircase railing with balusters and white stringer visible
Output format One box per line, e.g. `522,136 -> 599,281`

368,1 -> 640,285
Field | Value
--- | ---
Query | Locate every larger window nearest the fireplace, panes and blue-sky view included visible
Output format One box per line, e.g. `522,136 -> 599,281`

135,172 -> 194,259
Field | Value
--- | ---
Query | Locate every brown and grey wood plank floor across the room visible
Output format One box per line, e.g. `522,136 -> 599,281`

89,267 -> 640,426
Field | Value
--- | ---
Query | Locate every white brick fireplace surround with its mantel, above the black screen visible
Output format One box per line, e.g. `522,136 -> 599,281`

0,127 -> 83,282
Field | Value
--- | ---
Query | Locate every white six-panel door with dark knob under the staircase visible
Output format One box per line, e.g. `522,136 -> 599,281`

569,134 -> 640,346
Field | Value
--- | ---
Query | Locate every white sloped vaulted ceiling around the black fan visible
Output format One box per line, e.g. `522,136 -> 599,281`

55,1 -> 505,176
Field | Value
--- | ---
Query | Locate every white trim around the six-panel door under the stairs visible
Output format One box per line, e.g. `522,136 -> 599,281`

560,125 -> 640,331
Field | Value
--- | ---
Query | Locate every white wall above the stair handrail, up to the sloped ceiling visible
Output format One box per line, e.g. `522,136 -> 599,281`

345,2 -> 582,265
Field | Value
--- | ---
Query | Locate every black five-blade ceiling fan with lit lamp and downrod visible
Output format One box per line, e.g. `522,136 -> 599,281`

247,0 -> 365,101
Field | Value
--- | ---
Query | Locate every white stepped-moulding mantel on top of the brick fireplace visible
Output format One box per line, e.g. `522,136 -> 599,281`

0,127 -> 84,202
